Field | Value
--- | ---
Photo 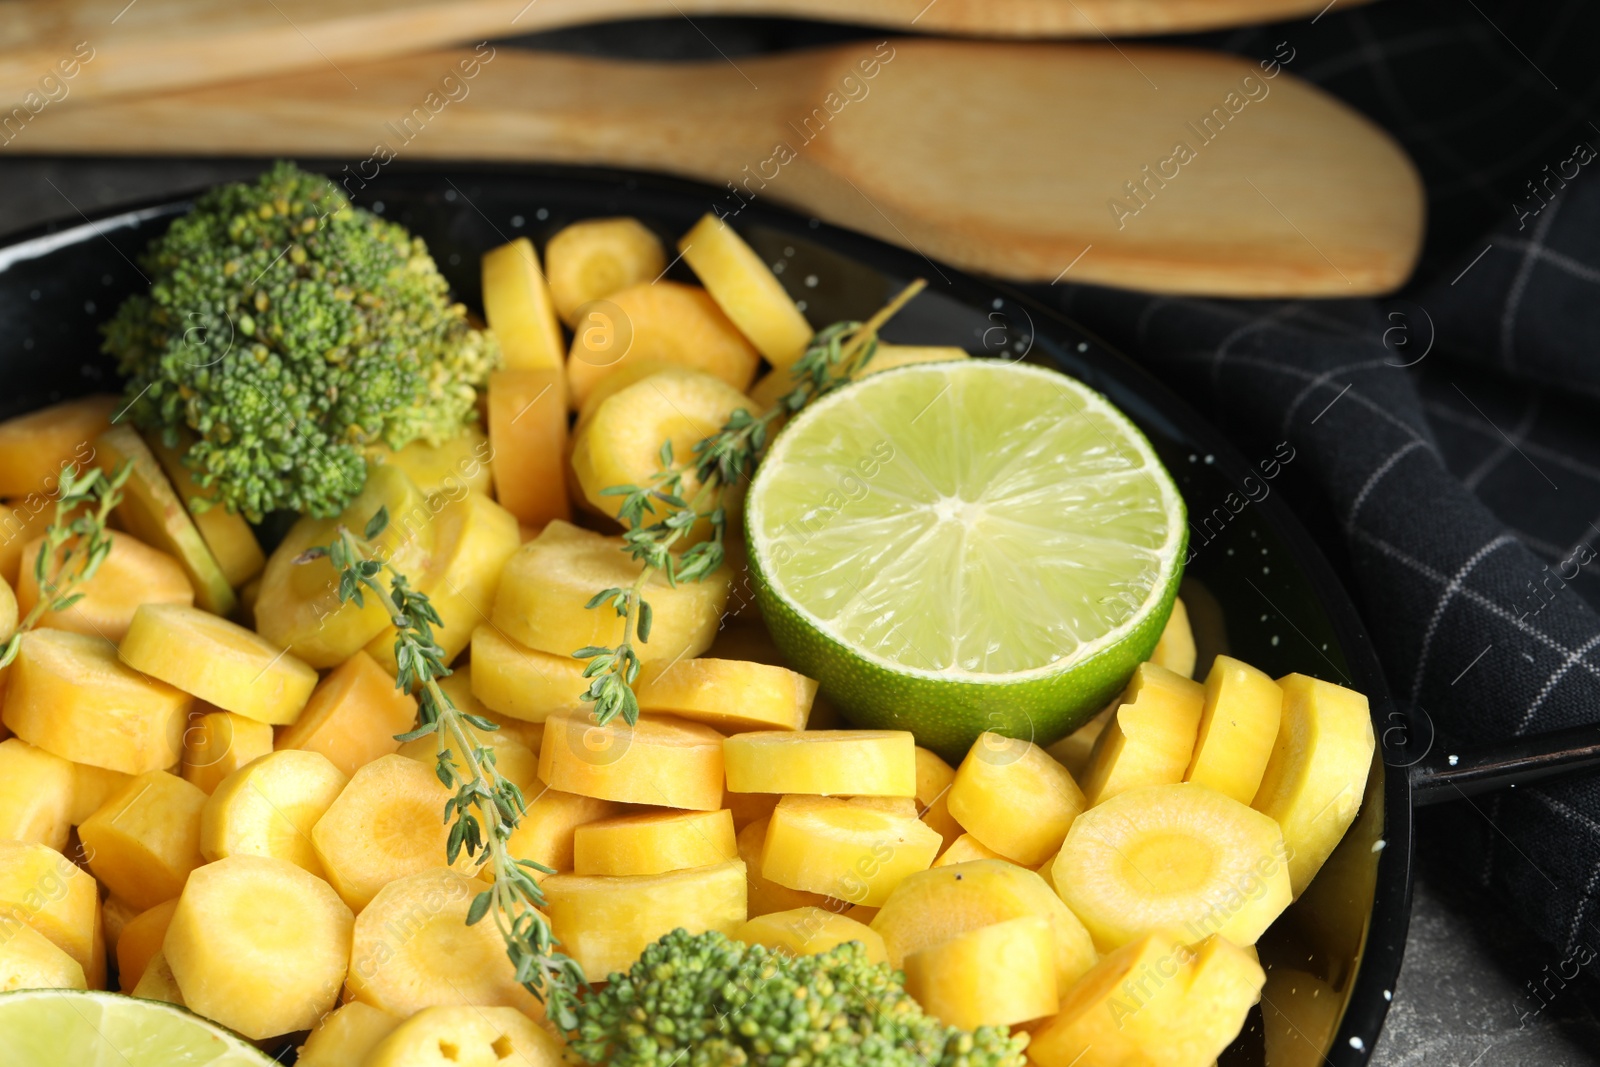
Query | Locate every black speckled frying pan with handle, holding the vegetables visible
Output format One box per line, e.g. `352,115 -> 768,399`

0,163 -> 1580,1067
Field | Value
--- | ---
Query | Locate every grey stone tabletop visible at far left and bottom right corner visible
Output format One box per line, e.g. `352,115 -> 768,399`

0,155 -> 1600,1067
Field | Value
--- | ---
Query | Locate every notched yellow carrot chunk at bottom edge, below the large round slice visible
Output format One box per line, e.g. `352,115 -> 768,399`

1027,934 -> 1266,1067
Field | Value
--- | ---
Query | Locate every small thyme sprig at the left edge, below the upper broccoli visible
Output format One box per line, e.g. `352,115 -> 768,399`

0,462 -> 133,667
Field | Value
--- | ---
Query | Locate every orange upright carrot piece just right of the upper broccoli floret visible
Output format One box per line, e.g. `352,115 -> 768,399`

488,368 -> 571,526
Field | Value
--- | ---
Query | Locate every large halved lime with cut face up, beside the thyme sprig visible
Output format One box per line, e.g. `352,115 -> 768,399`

746,360 -> 1187,760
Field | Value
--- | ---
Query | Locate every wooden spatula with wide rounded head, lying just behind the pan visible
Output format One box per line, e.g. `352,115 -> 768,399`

11,38 -> 1422,296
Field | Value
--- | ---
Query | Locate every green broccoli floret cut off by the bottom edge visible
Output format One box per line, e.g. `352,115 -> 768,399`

568,929 -> 1027,1067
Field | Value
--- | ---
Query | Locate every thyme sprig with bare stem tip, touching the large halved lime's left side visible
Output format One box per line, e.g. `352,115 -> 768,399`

573,278 -> 926,726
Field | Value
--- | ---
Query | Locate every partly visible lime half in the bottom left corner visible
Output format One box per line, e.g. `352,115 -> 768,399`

0,989 -> 274,1067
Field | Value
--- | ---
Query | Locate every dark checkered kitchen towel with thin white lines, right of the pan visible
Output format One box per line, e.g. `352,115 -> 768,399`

1045,0 -> 1600,960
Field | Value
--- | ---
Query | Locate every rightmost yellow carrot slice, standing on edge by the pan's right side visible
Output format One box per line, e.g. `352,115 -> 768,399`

1248,673 -> 1373,896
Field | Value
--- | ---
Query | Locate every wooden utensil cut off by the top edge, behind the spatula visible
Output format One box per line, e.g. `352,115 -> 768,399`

0,0 -> 1365,107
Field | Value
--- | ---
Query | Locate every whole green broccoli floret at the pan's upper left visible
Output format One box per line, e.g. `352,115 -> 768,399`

104,163 -> 499,520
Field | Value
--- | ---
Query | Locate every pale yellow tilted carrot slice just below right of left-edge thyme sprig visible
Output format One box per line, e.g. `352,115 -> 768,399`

117,603 -> 317,725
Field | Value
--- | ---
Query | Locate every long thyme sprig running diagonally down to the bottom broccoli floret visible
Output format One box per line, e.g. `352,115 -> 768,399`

296,507 -> 587,1030
